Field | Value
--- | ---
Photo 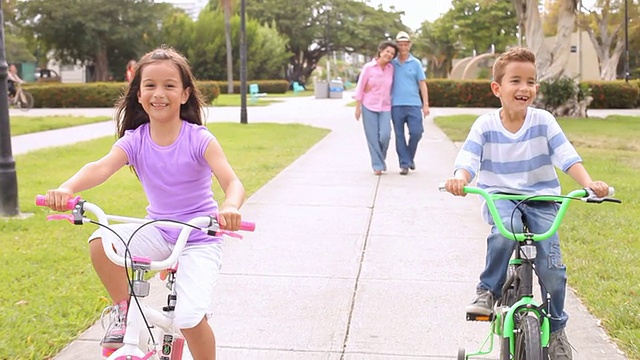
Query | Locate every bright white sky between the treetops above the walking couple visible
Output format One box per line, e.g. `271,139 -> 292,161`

376,0 -> 595,30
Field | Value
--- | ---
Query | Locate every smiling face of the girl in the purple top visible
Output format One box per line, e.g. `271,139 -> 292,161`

138,60 -> 191,121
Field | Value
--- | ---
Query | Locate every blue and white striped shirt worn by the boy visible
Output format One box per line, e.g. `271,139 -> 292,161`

455,107 -> 582,195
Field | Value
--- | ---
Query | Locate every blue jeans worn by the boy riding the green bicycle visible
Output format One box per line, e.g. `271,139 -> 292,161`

478,200 -> 569,332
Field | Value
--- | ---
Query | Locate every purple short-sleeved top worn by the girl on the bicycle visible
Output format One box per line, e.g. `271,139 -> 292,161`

115,121 -> 221,244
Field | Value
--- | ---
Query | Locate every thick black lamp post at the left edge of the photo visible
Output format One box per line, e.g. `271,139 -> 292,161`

0,1 -> 19,216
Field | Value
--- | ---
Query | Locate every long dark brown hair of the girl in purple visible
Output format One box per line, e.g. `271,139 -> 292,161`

116,46 -> 204,138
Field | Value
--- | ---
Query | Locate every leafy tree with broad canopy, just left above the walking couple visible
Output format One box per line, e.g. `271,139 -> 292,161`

247,0 -> 408,83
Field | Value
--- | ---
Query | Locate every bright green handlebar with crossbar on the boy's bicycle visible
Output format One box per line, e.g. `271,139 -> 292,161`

464,186 -> 587,241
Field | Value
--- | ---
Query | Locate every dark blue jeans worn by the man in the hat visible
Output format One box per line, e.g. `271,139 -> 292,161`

391,106 -> 424,168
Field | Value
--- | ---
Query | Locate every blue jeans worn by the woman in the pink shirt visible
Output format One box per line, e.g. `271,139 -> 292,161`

362,106 -> 391,171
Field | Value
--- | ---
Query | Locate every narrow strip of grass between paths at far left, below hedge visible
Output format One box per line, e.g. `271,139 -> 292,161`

9,116 -> 110,136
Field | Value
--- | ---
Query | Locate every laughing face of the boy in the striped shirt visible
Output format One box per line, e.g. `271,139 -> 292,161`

491,61 -> 540,111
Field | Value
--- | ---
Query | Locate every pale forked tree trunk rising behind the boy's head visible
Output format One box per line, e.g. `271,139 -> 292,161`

512,0 -> 578,81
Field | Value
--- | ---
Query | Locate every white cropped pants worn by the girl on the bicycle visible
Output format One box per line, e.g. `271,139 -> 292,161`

89,224 -> 222,329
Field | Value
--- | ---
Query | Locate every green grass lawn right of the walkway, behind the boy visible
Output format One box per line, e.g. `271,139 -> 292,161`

435,115 -> 640,360
